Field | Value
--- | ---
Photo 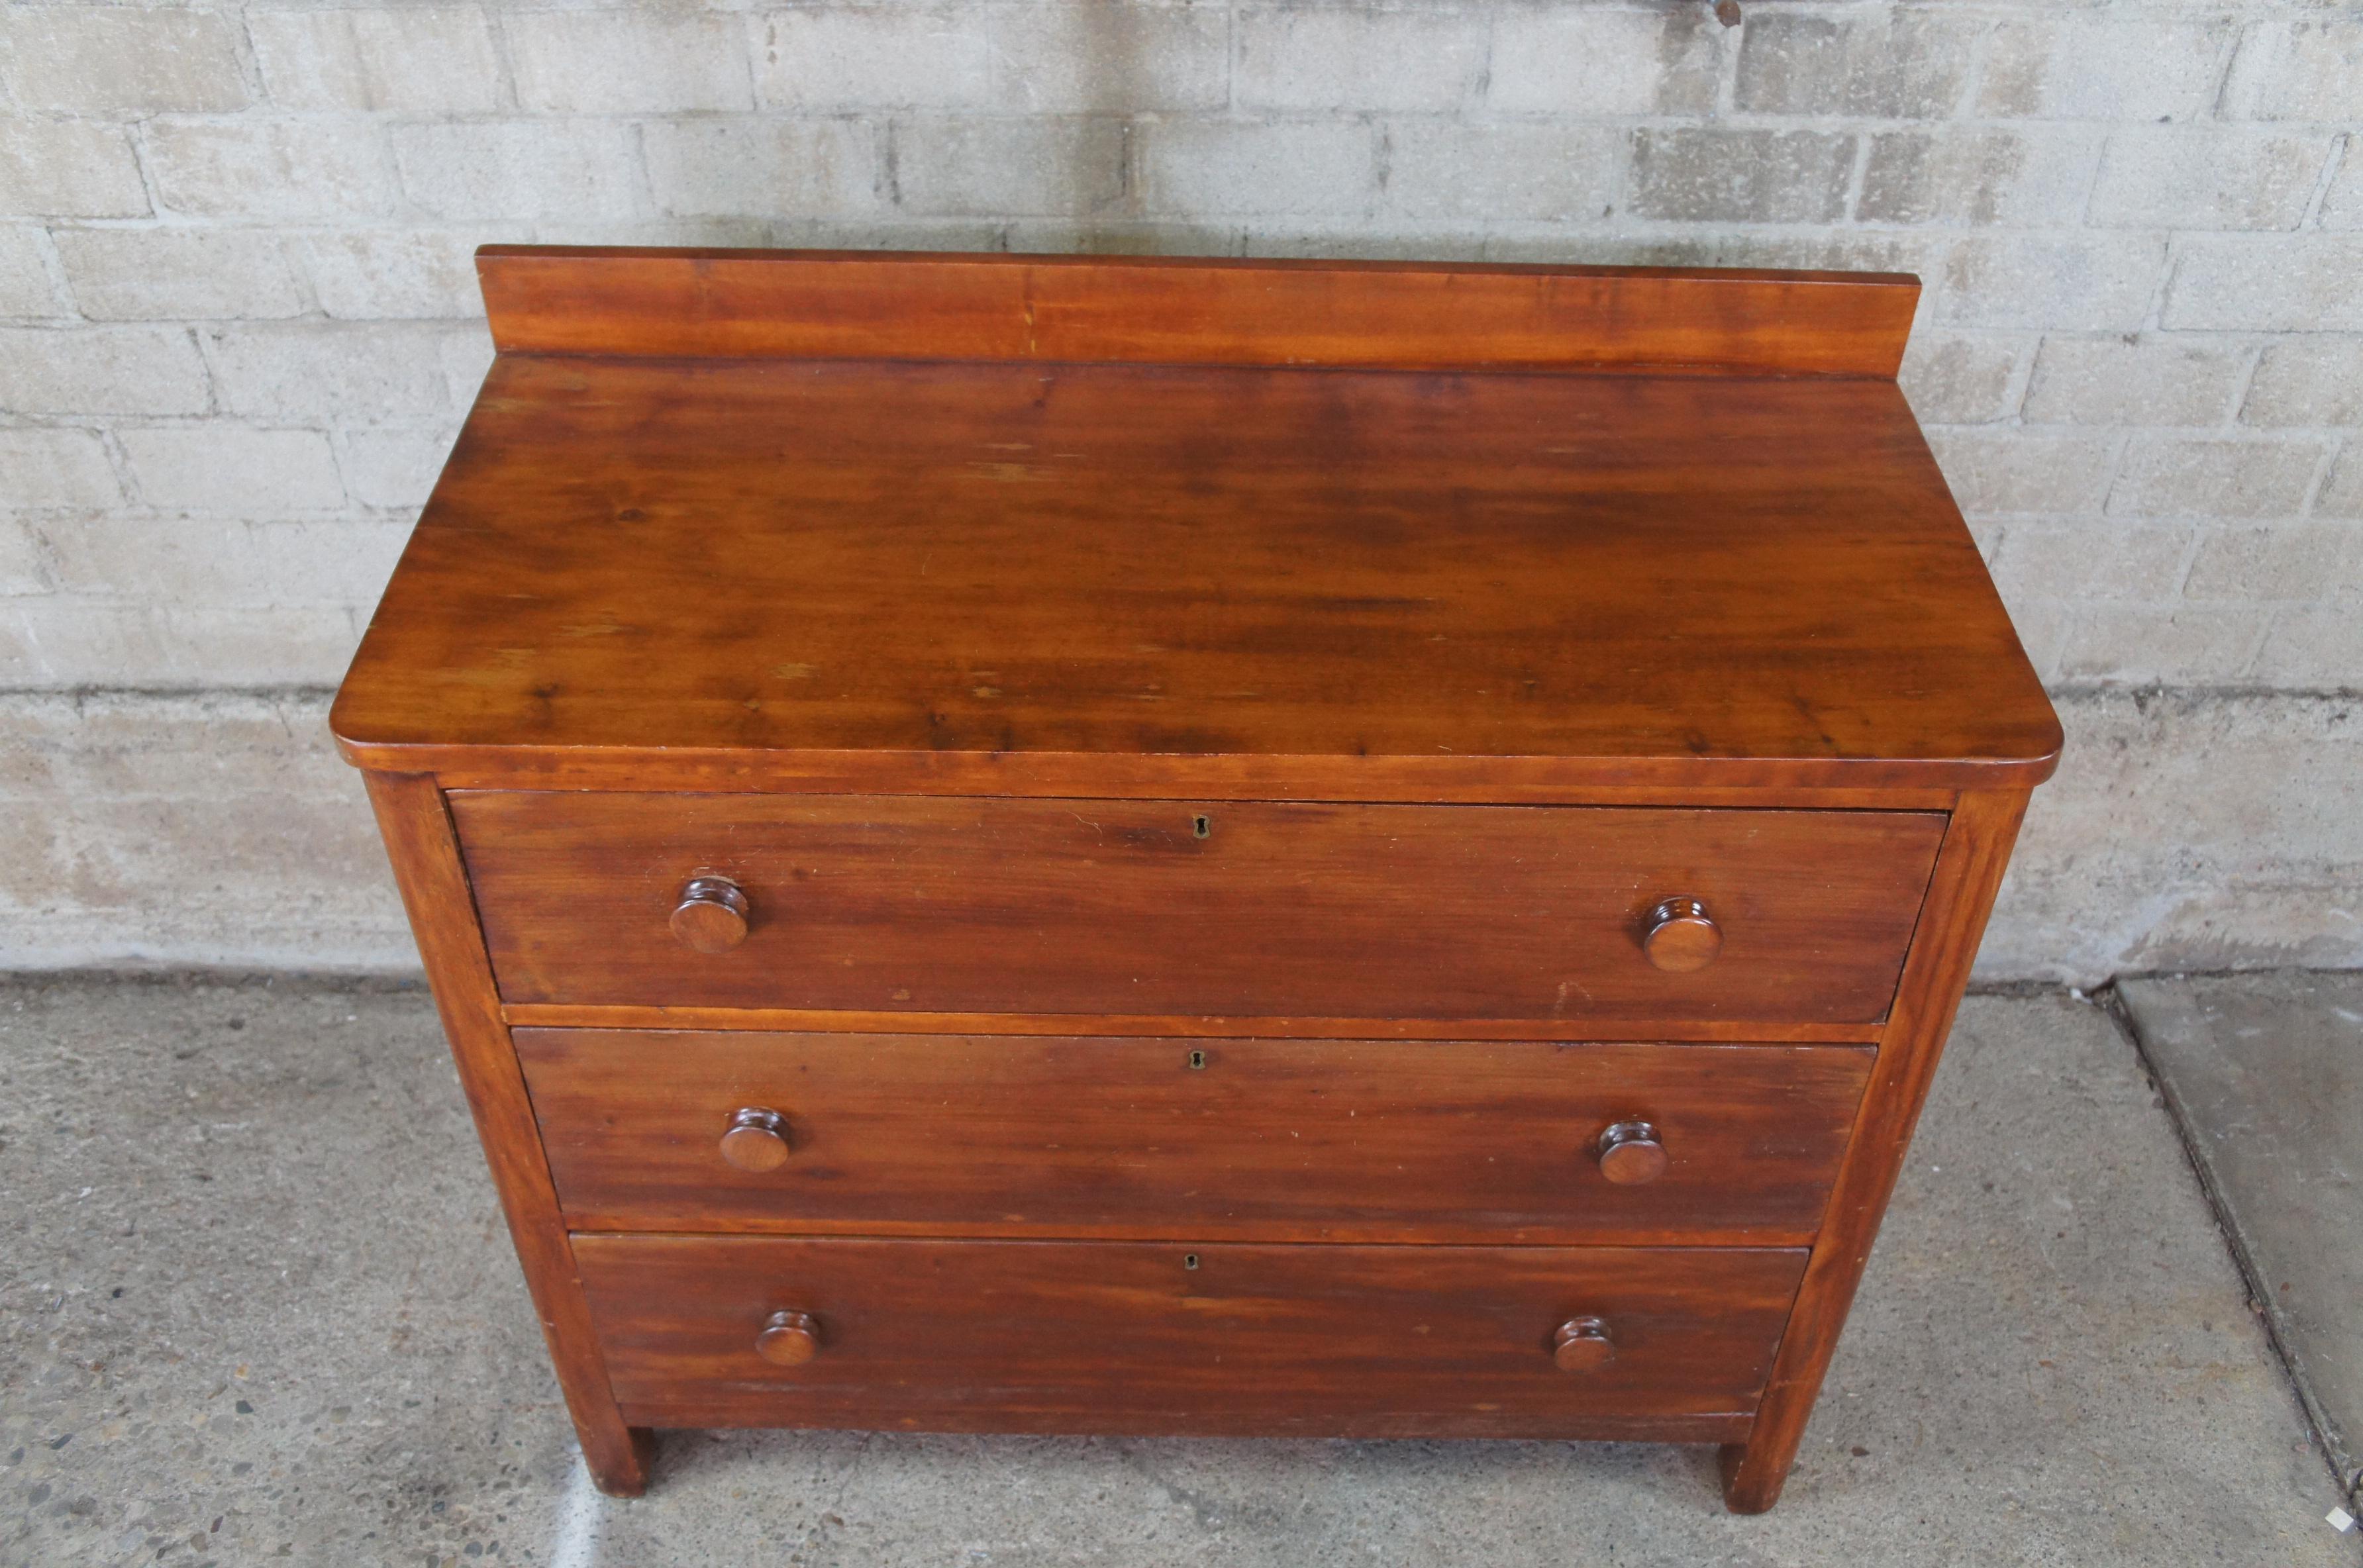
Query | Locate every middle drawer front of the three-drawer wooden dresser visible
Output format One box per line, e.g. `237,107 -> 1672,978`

515,1030 -> 1872,1242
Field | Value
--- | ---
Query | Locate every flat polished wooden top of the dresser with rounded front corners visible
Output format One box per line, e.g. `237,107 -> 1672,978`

333,256 -> 2058,787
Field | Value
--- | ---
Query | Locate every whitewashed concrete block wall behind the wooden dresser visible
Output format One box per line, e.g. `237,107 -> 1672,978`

0,0 -> 2363,980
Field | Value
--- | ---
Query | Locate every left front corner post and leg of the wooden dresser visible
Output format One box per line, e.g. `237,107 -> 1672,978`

354,772 -> 652,1497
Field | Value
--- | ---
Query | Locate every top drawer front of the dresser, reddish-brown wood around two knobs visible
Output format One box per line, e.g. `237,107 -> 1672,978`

451,791 -> 1944,1025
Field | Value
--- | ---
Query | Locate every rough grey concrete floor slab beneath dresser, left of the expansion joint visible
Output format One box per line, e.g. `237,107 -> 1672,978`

0,980 -> 2363,1568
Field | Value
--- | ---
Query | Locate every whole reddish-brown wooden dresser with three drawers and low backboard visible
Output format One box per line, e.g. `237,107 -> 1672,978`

333,248 -> 2060,1511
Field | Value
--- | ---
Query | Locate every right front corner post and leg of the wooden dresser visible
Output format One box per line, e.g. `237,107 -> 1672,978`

1723,793 -> 2027,1514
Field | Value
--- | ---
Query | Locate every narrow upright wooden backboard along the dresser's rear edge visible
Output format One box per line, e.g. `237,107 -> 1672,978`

478,246 -> 1919,378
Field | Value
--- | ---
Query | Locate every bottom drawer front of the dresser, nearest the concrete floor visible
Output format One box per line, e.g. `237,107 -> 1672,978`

574,1235 -> 1805,1440
